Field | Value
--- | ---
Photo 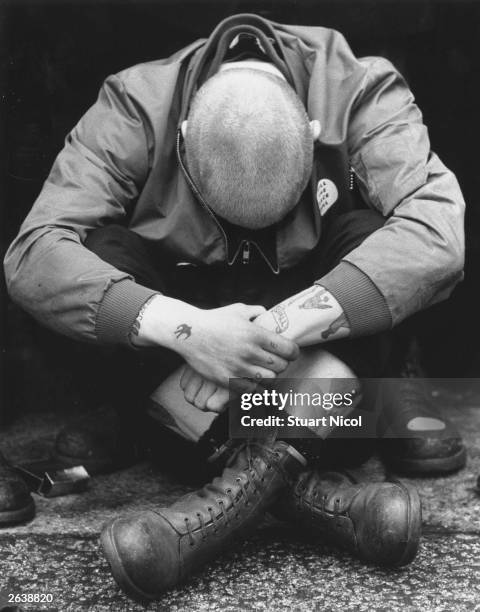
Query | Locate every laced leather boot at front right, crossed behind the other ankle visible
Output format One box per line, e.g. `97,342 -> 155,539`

274,470 -> 422,566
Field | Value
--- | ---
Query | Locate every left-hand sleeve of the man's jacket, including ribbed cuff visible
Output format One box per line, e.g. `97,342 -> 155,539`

5,76 -> 158,344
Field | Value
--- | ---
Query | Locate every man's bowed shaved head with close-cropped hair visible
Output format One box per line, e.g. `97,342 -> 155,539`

185,68 -> 313,229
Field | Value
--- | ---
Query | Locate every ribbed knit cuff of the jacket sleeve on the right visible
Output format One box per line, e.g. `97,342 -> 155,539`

315,261 -> 392,337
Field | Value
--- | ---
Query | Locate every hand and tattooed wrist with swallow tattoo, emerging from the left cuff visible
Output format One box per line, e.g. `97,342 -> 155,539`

132,295 -> 298,392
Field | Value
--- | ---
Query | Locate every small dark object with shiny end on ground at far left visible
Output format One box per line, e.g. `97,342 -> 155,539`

14,461 -> 90,497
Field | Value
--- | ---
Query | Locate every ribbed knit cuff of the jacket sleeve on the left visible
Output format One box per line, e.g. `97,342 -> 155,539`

95,279 -> 158,347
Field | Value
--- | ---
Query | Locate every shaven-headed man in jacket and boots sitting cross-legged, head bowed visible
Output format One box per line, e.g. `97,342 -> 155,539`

6,15 -> 463,599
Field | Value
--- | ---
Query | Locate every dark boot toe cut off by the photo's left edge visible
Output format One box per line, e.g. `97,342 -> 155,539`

0,453 -> 35,527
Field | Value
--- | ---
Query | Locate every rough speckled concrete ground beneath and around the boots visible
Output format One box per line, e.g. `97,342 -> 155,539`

0,395 -> 480,612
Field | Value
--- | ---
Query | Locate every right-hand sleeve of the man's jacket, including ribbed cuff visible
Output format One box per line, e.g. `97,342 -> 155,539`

317,58 -> 465,335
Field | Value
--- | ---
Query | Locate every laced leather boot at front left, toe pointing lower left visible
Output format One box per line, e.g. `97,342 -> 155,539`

101,441 -> 305,600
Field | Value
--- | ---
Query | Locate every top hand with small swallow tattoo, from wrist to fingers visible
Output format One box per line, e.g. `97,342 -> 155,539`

174,304 -> 299,392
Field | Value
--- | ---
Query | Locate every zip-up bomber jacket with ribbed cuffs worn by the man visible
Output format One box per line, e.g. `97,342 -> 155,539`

5,15 -> 464,344
